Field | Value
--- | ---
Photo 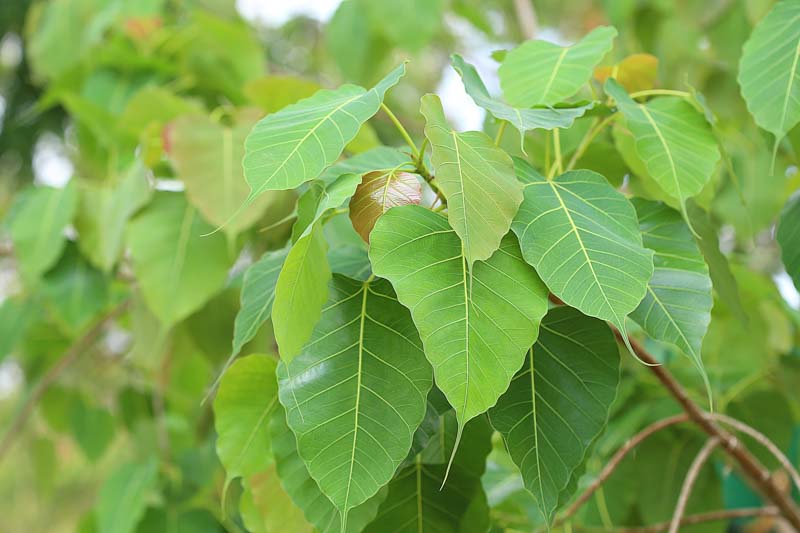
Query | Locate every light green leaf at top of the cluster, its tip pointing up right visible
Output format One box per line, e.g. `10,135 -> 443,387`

498,26 -> 617,107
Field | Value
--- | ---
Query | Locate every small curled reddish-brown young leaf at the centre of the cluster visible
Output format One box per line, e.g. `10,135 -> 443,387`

350,170 -> 422,243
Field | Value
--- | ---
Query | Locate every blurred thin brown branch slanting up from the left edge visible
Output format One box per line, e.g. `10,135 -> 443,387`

0,300 -> 130,461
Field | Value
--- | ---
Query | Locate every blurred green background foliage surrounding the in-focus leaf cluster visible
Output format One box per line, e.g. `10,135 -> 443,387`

0,0 -> 800,533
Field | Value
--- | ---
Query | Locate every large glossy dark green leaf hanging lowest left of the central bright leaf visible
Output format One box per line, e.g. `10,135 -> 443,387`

278,274 -> 431,523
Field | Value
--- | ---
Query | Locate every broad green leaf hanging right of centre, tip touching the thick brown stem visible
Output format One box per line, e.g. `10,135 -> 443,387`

512,162 -> 653,340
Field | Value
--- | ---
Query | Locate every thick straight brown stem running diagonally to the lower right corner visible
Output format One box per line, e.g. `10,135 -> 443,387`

611,326 -> 800,531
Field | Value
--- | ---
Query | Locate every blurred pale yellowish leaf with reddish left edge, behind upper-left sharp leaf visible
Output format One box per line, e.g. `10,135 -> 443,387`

169,108 -> 275,238
